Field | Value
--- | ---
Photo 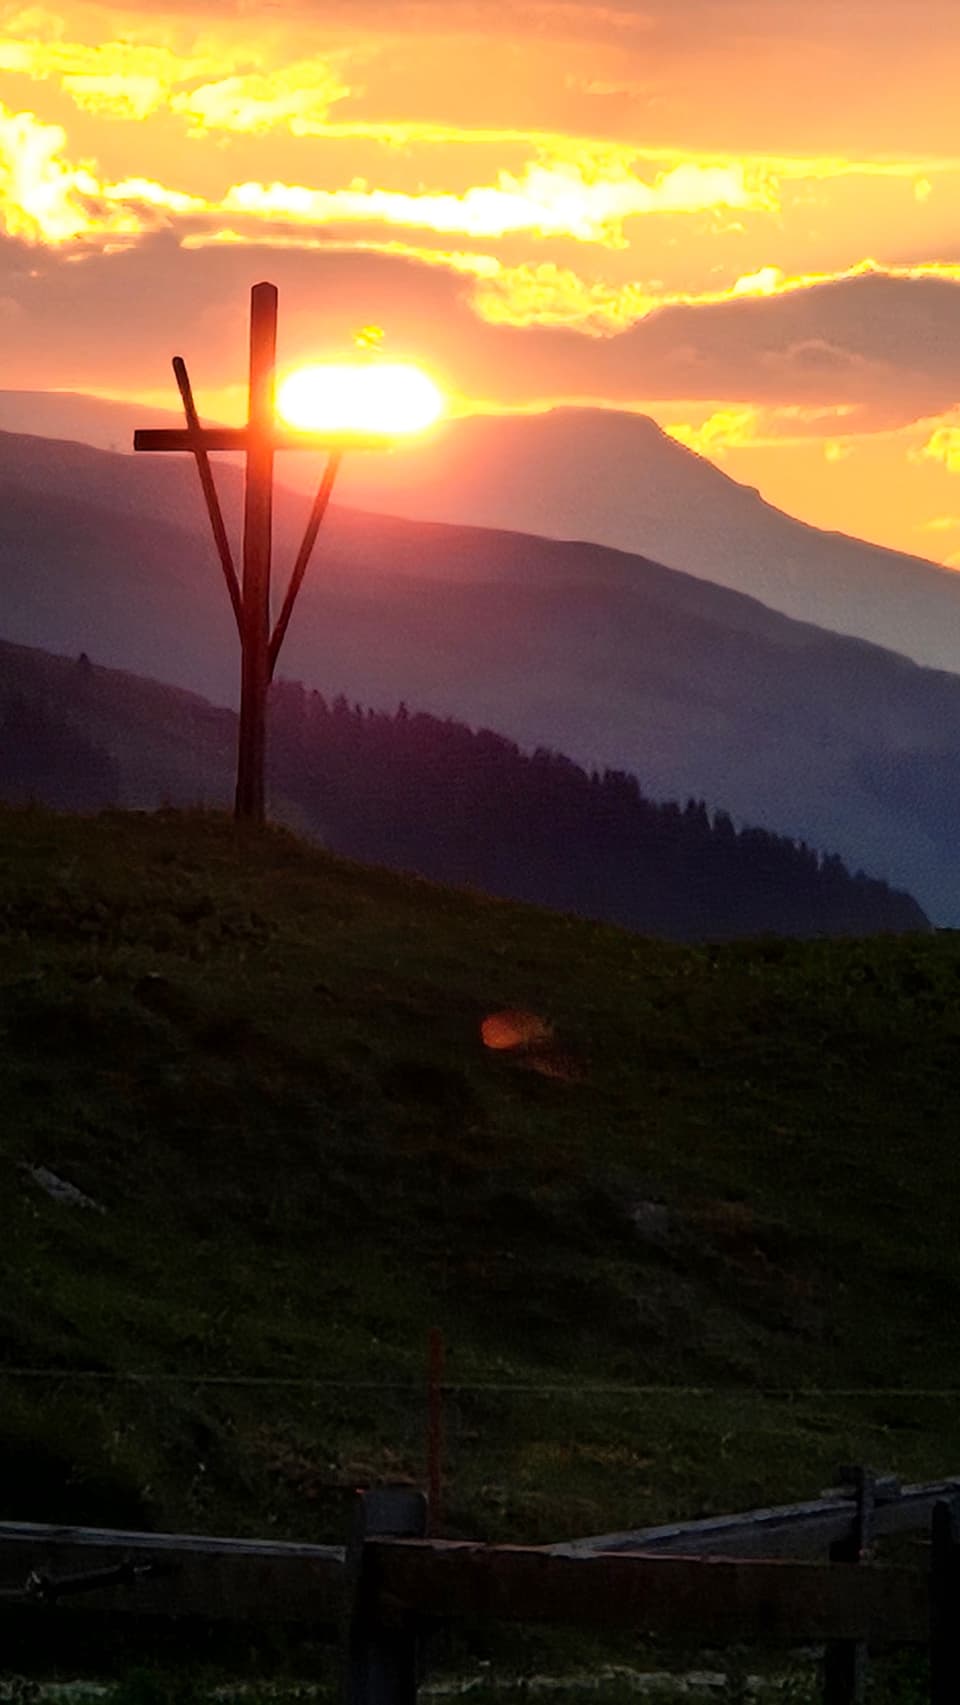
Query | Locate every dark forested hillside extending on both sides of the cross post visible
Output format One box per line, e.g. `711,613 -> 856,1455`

0,646 -> 926,939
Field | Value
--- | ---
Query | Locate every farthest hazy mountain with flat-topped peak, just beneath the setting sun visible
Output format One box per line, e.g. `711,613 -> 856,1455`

0,387 -> 960,672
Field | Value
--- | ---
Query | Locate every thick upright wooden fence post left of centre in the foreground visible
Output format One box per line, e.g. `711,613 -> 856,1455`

343,1487 -> 426,1705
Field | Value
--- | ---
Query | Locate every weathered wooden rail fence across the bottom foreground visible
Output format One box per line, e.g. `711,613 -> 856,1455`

0,1473 -> 960,1705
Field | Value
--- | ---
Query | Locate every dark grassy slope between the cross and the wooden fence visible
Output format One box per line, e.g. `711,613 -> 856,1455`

0,812 -> 960,1540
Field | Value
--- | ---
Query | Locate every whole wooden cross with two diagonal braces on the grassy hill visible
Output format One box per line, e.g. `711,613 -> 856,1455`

133,285 -> 392,824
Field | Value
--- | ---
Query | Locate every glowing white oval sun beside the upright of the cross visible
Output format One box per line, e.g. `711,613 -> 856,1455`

276,363 -> 443,435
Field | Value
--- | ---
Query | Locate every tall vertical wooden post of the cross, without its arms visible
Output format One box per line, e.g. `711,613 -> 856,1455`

235,285 -> 278,824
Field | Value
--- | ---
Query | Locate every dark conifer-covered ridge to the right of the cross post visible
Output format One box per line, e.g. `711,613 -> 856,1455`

271,682 -> 926,941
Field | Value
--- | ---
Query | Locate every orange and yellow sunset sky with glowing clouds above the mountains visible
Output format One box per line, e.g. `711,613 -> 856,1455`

0,0 -> 960,566
